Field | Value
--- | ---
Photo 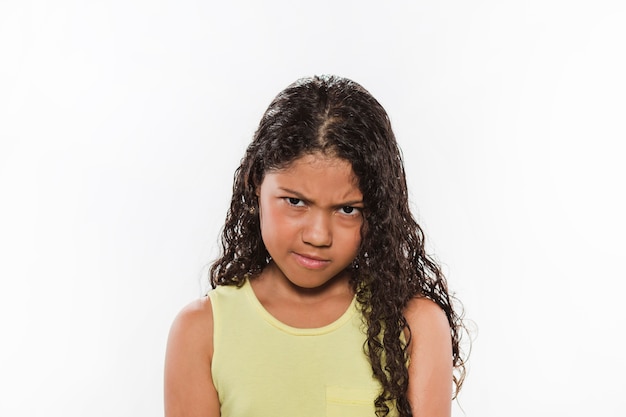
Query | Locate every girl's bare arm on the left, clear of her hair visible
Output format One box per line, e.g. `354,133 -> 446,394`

165,297 -> 220,417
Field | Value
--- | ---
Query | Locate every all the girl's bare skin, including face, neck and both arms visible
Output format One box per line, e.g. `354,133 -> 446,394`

165,154 -> 452,417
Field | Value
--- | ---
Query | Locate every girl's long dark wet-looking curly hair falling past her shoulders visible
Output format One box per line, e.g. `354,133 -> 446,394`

210,76 -> 465,416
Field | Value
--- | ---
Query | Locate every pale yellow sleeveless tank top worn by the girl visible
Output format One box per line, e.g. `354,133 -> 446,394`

209,281 -> 395,417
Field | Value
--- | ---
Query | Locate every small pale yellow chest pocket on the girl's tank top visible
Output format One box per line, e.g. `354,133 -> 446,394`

326,386 -> 379,417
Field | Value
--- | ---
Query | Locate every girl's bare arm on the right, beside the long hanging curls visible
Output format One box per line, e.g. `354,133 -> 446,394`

405,298 -> 452,417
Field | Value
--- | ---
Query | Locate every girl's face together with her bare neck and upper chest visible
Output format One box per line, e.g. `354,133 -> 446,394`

251,155 -> 363,328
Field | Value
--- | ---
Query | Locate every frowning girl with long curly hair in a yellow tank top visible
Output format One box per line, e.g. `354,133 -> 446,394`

165,76 -> 465,417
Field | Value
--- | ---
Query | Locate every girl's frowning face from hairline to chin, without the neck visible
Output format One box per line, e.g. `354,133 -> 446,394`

257,153 -> 363,289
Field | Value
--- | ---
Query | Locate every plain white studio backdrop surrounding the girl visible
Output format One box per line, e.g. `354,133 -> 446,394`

0,0 -> 626,417
